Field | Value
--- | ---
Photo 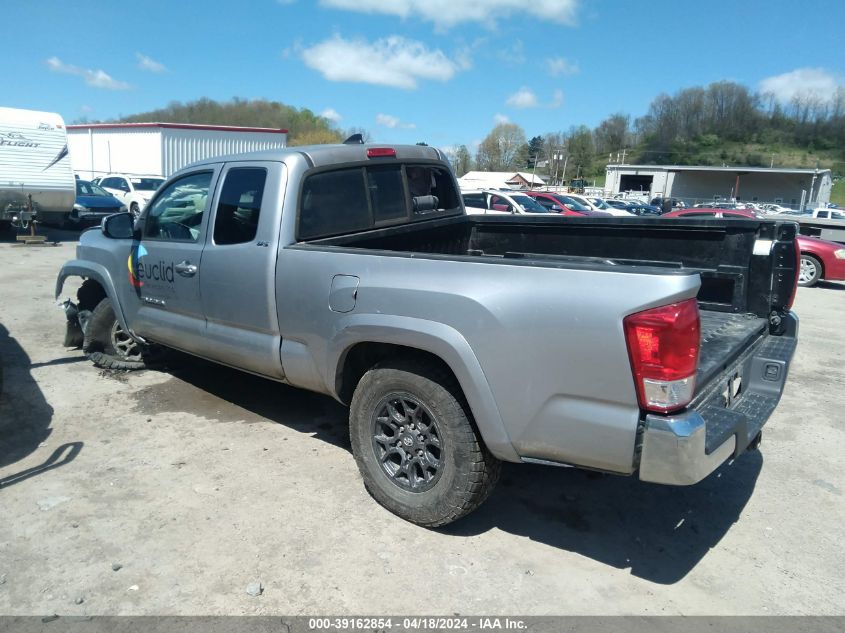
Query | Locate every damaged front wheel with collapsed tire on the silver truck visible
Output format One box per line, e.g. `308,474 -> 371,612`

82,298 -> 147,370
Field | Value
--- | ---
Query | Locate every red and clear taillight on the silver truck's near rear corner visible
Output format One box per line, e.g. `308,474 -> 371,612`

623,299 -> 701,413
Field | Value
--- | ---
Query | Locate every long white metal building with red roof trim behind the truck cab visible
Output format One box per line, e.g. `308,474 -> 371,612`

67,123 -> 288,180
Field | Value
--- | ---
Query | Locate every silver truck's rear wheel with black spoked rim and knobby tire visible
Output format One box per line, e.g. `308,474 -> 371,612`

349,360 -> 501,527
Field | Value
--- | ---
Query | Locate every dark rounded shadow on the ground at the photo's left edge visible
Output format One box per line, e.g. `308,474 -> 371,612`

0,324 -> 63,468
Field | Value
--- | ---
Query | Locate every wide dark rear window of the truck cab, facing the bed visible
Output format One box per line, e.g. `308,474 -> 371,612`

297,162 -> 461,240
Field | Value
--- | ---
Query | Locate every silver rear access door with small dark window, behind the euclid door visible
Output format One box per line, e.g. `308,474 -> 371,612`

199,161 -> 286,378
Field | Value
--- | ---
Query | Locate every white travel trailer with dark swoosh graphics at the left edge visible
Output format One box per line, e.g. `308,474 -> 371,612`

0,108 -> 76,228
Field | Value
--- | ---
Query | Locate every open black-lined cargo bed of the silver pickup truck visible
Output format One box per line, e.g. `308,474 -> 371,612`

313,216 -> 795,404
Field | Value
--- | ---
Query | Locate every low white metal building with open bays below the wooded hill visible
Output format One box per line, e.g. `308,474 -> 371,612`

605,165 -> 833,207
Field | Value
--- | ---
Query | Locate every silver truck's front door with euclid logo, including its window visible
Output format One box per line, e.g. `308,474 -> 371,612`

122,167 -> 219,353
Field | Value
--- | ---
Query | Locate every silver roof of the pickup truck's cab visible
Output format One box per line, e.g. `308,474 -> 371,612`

179,143 -> 446,167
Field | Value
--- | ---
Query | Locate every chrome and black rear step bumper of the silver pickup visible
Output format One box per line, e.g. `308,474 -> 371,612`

639,314 -> 798,486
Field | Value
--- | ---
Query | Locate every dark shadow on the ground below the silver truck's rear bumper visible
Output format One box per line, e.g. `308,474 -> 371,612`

445,451 -> 763,584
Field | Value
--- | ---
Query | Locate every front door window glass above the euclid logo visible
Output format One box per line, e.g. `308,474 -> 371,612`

144,171 -> 212,242
